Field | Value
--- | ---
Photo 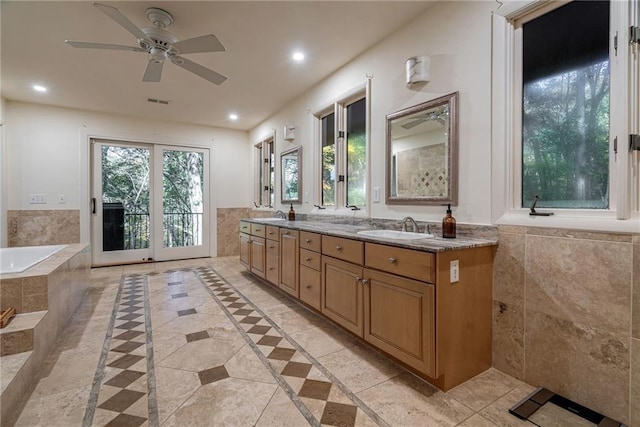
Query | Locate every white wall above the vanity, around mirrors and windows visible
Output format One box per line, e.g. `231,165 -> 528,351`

250,1 -> 497,224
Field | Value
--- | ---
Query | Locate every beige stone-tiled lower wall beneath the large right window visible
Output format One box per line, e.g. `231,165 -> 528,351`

493,226 -> 640,426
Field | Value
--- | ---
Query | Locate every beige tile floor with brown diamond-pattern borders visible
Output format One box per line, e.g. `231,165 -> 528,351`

5,257 -> 576,427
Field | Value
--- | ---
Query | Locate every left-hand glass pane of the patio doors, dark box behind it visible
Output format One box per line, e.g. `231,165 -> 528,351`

101,145 -> 150,252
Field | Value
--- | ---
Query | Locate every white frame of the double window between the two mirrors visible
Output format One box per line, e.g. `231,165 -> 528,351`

313,78 -> 371,215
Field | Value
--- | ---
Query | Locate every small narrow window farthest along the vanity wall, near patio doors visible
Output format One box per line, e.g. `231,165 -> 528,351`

254,137 -> 276,208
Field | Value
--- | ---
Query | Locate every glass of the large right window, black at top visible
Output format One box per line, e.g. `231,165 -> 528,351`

521,1 -> 609,209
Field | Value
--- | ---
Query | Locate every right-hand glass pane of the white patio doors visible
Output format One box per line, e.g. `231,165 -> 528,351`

162,150 -> 204,248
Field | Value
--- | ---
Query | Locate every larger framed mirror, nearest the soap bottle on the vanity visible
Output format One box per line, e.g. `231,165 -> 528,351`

386,92 -> 458,206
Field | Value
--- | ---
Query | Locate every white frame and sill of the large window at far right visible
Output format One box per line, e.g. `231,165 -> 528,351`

491,0 -> 640,232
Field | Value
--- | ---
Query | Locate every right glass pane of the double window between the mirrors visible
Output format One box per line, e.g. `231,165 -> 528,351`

347,98 -> 367,206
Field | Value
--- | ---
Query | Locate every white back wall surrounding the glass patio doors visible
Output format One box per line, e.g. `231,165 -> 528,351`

2,101 -> 251,253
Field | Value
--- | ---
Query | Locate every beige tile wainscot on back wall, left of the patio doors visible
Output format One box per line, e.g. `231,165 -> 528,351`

7,210 -> 80,247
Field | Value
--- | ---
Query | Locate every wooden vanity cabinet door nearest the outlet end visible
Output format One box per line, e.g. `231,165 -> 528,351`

364,269 -> 435,377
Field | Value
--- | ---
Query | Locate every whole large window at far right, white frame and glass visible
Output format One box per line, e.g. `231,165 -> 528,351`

491,0 -> 640,224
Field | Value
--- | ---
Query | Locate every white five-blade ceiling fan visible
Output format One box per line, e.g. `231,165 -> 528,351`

64,2 -> 227,85
